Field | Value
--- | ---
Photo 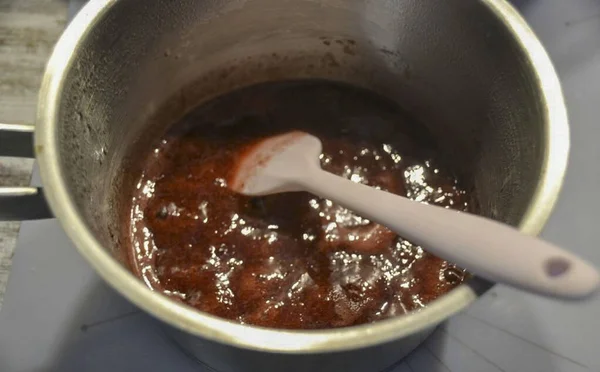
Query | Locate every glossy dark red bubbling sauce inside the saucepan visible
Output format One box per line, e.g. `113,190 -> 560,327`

123,81 -> 470,329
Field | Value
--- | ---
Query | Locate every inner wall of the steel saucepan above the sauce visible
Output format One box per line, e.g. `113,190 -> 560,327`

57,0 -> 545,264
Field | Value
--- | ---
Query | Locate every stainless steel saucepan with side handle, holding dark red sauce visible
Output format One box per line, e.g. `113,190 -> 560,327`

0,0 -> 569,372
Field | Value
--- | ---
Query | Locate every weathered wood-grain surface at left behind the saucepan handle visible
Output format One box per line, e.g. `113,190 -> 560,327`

0,0 -> 68,307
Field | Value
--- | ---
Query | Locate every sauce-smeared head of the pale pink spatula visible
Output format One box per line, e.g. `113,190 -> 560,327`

229,131 -> 322,196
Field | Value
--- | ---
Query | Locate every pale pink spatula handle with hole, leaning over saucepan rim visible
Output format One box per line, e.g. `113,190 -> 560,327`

298,169 -> 600,299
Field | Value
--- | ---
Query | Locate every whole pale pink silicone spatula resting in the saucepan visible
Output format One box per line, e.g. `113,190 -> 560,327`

230,132 -> 600,299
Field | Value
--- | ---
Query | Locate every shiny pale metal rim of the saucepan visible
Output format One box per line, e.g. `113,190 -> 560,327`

35,0 -> 569,353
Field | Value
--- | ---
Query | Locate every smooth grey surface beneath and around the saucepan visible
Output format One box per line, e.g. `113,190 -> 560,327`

0,0 -> 600,372
